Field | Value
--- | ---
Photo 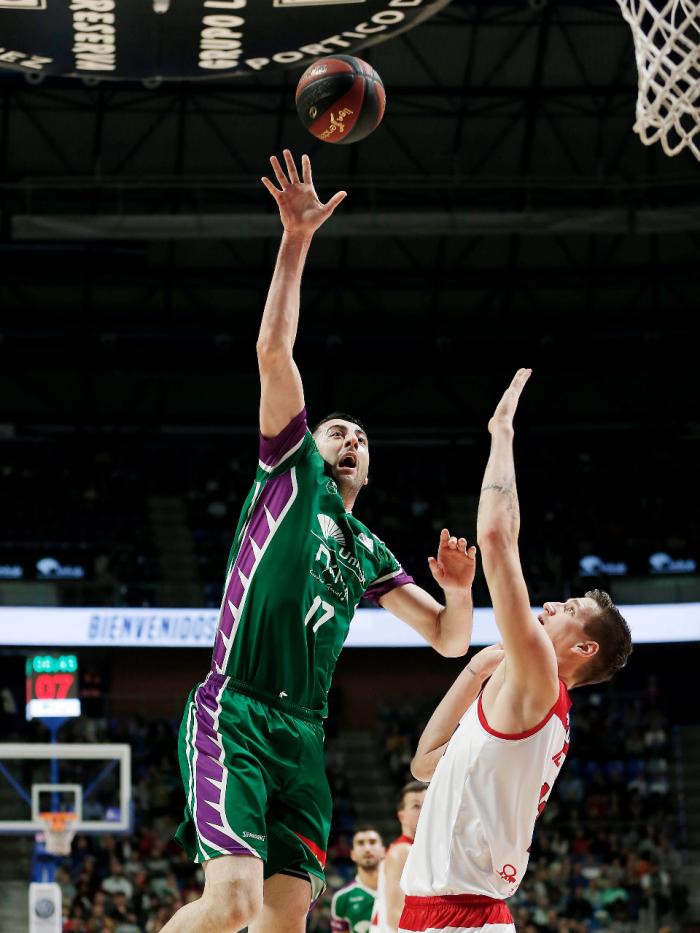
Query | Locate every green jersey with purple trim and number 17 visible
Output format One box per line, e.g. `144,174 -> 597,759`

212,411 -> 411,718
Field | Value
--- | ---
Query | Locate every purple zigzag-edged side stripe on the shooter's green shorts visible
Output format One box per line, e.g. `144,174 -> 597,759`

193,674 -> 252,855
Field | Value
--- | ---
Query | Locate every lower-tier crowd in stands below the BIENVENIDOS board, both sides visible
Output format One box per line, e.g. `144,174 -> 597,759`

8,664 -> 688,933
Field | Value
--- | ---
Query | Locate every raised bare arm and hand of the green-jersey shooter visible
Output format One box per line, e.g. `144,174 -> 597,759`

257,149 -> 346,437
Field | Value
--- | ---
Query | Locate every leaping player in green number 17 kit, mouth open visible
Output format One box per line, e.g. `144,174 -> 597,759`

165,150 -> 475,933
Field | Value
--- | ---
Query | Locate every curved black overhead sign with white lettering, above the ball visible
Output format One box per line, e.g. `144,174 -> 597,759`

0,0 -> 449,80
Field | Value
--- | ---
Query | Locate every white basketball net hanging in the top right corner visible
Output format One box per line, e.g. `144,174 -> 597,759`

617,0 -> 700,159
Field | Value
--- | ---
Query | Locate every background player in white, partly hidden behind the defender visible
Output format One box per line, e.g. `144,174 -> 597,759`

370,781 -> 426,933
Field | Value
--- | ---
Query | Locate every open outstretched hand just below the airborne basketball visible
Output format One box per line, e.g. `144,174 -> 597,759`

262,149 -> 347,236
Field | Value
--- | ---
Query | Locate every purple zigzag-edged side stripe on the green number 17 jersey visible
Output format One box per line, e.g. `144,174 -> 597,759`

213,472 -> 295,671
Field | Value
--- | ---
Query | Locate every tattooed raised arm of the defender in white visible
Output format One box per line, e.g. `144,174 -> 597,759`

477,369 -> 558,718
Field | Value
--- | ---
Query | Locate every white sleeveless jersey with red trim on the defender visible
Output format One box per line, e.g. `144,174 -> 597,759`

401,682 -> 571,900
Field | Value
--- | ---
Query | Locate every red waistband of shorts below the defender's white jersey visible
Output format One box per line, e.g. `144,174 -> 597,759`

399,894 -> 513,933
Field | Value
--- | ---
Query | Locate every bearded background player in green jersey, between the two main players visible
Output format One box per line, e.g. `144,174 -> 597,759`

331,826 -> 384,933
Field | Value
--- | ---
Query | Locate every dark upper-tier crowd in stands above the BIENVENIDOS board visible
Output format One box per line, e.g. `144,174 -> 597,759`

0,432 -> 700,607
